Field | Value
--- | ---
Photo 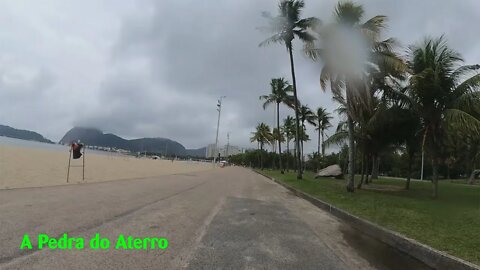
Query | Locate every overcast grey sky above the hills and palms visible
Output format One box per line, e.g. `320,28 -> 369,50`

0,0 -> 480,152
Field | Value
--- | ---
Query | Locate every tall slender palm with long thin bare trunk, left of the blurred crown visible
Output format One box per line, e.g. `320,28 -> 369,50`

260,0 -> 320,179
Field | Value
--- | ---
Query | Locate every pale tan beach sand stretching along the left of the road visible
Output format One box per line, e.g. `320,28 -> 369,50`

0,145 -> 213,189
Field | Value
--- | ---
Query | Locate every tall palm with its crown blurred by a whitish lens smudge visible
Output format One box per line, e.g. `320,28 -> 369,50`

306,1 -> 404,192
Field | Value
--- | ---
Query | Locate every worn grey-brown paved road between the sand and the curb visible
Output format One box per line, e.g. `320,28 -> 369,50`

0,167 -> 432,269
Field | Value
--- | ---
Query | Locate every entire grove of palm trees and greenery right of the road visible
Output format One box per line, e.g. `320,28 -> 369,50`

230,0 -> 480,198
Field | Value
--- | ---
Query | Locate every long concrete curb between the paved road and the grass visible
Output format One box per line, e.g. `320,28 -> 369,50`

254,170 -> 480,270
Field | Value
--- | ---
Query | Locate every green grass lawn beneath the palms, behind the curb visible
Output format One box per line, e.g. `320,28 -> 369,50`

262,170 -> 480,265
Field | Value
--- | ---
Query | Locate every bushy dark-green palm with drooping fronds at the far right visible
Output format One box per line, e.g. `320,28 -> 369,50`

400,36 -> 480,198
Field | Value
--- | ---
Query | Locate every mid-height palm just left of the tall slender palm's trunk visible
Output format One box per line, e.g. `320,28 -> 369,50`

260,78 -> 294,174
